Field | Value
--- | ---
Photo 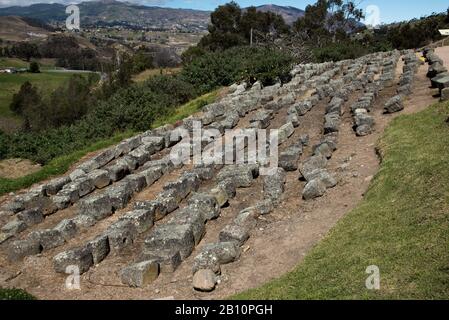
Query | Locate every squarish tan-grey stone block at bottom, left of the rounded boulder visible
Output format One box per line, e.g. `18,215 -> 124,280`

120,261 -> 159,288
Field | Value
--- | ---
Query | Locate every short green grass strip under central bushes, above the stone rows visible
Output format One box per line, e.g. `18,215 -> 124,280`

152,89 -> 221,128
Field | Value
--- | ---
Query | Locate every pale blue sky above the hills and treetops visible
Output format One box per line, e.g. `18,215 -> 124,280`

0,0 -> 449,23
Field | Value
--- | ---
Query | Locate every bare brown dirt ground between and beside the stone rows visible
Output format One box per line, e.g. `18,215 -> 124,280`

0,47 -> 449,300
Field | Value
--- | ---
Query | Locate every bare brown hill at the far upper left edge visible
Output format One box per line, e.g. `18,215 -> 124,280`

0,16 -> 53,41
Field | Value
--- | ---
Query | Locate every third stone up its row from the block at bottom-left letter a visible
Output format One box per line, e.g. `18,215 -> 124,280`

106,220 -> 138,253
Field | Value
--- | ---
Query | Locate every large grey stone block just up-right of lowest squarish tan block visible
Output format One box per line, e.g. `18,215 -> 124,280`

145,224 -> 194,260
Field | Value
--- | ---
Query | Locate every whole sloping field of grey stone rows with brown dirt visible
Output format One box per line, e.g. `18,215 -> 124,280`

0,45 -> 442,299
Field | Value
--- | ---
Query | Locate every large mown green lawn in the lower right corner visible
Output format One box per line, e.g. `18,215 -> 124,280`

233,100 -> 449,299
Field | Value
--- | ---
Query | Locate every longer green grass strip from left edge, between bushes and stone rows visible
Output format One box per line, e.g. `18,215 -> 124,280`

0,132 -> 136,195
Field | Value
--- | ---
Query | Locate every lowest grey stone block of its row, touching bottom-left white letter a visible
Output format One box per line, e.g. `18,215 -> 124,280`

53,247 -> 93,274
